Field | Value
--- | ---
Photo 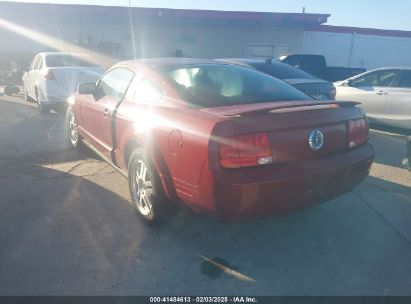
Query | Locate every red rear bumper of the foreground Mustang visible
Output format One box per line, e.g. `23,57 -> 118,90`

215,144 -> 374,222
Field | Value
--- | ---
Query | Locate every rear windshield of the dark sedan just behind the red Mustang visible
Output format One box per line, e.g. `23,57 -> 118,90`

249,62 -> 314,79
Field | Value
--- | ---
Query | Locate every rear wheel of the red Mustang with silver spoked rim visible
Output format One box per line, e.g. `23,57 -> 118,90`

128,148 -> 166,224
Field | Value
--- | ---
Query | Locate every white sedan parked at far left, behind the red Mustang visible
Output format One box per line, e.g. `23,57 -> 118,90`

23,52 -> 104,114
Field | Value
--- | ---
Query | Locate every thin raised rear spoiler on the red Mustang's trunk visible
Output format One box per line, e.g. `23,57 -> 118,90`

227,101 -> 361,116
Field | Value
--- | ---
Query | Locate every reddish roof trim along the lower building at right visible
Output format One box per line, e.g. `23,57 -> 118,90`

307,25 -> 411,38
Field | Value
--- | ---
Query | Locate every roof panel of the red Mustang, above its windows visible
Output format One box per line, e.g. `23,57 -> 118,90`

117,57 -> 222,70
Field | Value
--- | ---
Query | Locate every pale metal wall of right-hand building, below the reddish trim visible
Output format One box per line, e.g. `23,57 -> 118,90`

303,31 -> 411,69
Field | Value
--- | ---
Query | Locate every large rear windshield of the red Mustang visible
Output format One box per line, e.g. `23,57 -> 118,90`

164,64 -> 312,108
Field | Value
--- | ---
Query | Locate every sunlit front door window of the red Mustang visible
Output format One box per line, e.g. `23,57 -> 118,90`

96,68 -> 134,100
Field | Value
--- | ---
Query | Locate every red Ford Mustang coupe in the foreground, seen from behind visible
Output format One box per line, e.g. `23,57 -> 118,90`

67,58 -> 374,222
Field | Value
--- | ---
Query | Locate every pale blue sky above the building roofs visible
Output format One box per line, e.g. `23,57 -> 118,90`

0,0 -> 411,31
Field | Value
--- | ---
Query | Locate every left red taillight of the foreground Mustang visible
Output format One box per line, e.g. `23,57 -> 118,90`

220,132 -> 273,168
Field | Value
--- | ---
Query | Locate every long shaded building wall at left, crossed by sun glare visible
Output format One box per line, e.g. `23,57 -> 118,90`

0,1 -> 316,68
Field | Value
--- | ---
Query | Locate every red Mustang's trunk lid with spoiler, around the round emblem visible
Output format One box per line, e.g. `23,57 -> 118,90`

207,101 -> 363,163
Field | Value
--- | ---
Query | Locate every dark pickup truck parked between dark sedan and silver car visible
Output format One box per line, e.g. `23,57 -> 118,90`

273,54 -> 365,82
